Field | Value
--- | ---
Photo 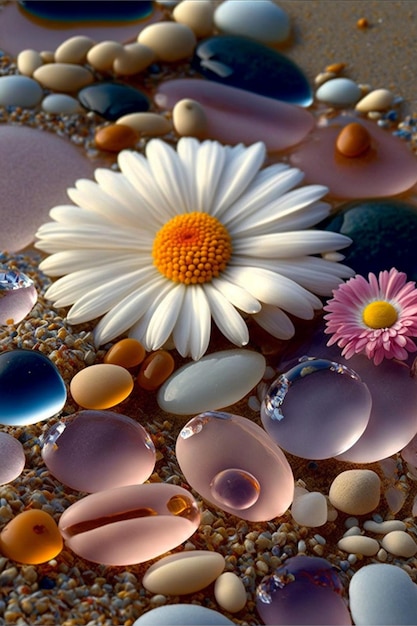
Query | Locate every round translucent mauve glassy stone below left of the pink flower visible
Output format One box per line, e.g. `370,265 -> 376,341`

261,359 -> 372,460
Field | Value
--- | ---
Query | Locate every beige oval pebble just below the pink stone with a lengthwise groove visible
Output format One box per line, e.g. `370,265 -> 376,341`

142,550 -> 225,596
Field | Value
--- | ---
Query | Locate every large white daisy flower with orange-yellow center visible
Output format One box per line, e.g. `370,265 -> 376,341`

36,137 -> 353,359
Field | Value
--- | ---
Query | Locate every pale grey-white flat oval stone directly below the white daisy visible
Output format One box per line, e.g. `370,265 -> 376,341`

157,349 -> 266,415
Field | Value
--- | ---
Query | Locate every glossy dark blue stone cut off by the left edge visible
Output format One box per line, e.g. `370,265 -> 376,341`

0,350 -> 67,426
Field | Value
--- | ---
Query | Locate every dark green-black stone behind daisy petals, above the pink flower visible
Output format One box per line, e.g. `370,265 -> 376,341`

321,198 -> 417,281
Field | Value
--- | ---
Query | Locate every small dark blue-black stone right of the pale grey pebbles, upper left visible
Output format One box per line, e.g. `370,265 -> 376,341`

78,81 -> 150,122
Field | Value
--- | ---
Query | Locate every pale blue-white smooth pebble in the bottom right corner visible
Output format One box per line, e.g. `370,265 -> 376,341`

349,563 -> 417,626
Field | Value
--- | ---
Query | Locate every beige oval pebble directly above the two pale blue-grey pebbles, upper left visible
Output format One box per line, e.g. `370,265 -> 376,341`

33,63 -> 94,93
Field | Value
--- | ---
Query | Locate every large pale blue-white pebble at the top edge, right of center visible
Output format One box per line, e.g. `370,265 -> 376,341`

214,0 -> 290,44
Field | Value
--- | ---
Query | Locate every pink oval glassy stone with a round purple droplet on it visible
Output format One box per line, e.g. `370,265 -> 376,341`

176,412 -> 294,521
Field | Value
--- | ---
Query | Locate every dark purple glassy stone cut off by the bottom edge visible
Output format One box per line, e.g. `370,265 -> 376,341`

256,556 -> 352,626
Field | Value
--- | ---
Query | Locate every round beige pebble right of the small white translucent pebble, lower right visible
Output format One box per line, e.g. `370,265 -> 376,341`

329,469 -> 381,515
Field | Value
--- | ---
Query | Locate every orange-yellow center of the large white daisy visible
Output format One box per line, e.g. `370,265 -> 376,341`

152,211 -> 232,285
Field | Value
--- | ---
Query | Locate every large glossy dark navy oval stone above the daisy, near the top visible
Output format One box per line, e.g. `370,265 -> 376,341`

191,35 -> 313,106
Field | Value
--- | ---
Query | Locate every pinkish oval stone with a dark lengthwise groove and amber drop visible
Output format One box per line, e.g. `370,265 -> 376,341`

59,483 -> 200,566
